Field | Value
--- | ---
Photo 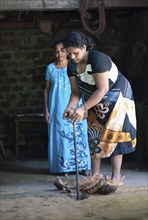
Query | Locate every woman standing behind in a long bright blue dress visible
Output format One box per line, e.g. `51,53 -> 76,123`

44,41 -> 91,174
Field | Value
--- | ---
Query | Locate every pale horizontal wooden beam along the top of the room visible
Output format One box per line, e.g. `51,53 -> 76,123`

0,0 -> 148,11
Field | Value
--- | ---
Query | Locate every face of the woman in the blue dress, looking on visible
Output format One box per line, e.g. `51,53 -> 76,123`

55,43 -> 67,61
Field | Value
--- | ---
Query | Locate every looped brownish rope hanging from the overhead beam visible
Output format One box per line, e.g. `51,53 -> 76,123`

79,0 -> 106,38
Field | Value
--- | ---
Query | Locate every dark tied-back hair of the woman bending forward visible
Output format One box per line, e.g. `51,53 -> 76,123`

64,31 -> 94,50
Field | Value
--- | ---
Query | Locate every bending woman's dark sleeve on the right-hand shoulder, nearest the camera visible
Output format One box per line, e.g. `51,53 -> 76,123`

89,50 -> 112,73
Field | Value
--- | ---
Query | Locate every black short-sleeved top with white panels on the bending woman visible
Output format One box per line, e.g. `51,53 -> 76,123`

67,50 -> 119,97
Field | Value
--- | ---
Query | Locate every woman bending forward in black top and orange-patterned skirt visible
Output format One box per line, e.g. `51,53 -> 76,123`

63,32 -> 136,192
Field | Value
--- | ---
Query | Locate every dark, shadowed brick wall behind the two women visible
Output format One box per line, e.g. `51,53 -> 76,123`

0,8 -> 148,158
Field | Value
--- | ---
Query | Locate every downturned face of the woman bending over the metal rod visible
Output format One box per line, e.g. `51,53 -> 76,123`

66,45 -> 86,63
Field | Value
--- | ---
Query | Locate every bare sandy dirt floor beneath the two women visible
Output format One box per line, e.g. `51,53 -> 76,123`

0,160 -> 148,220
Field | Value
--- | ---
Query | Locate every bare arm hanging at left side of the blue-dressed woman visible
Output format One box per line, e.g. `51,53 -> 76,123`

44,81 -> 51,124
